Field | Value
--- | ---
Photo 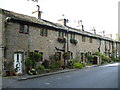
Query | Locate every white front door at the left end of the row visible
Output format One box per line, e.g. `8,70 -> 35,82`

14,53 -> 23,73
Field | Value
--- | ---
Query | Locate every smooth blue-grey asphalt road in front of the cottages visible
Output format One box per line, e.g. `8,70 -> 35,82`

3,63 -> 118,88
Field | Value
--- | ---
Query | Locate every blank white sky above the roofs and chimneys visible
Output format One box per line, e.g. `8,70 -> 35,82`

0,0 -> 119,39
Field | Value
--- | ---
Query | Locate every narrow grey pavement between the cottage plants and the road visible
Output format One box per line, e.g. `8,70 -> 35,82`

3,65 -> 99,81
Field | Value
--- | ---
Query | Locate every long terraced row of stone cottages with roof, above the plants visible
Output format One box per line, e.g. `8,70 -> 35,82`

0,9 -> 120,73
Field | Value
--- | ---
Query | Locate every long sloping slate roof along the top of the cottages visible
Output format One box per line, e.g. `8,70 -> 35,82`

0,8 -> 113,41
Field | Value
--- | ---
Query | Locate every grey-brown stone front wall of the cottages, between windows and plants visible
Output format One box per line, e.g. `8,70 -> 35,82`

0,10 -> 119,73
